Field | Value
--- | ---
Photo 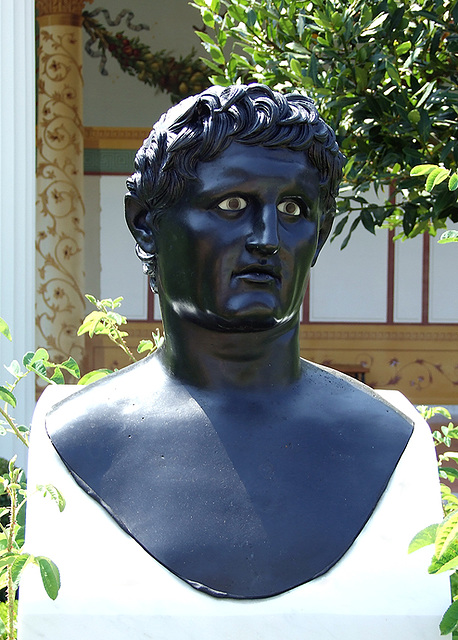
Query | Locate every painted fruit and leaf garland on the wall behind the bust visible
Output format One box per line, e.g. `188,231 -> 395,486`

83,8 -> 210,103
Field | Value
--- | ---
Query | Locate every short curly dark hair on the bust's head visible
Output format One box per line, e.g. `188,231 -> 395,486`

127,84 -> 345,219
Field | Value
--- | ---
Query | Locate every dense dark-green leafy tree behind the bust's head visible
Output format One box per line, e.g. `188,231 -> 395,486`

194,0 -> 458,244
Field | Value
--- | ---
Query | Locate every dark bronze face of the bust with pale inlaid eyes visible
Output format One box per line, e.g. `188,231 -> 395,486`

156,143 -> 329,331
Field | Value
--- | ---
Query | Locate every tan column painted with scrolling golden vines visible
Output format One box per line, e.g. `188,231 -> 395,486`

36,0 -> 91,364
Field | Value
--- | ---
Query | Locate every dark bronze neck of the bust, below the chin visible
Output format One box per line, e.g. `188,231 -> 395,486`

156,313 -> 300,391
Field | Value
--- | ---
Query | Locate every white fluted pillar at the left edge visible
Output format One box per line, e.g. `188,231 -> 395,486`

0,0 -> 35,465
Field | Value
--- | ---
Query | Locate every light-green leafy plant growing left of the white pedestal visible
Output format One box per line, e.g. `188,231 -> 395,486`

0,302 -> 163,640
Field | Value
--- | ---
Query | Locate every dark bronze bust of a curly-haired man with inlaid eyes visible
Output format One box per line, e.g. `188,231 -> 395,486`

46,84 -> 412,599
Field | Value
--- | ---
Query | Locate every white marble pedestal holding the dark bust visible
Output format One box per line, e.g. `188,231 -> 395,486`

19,387 -> 450,640
